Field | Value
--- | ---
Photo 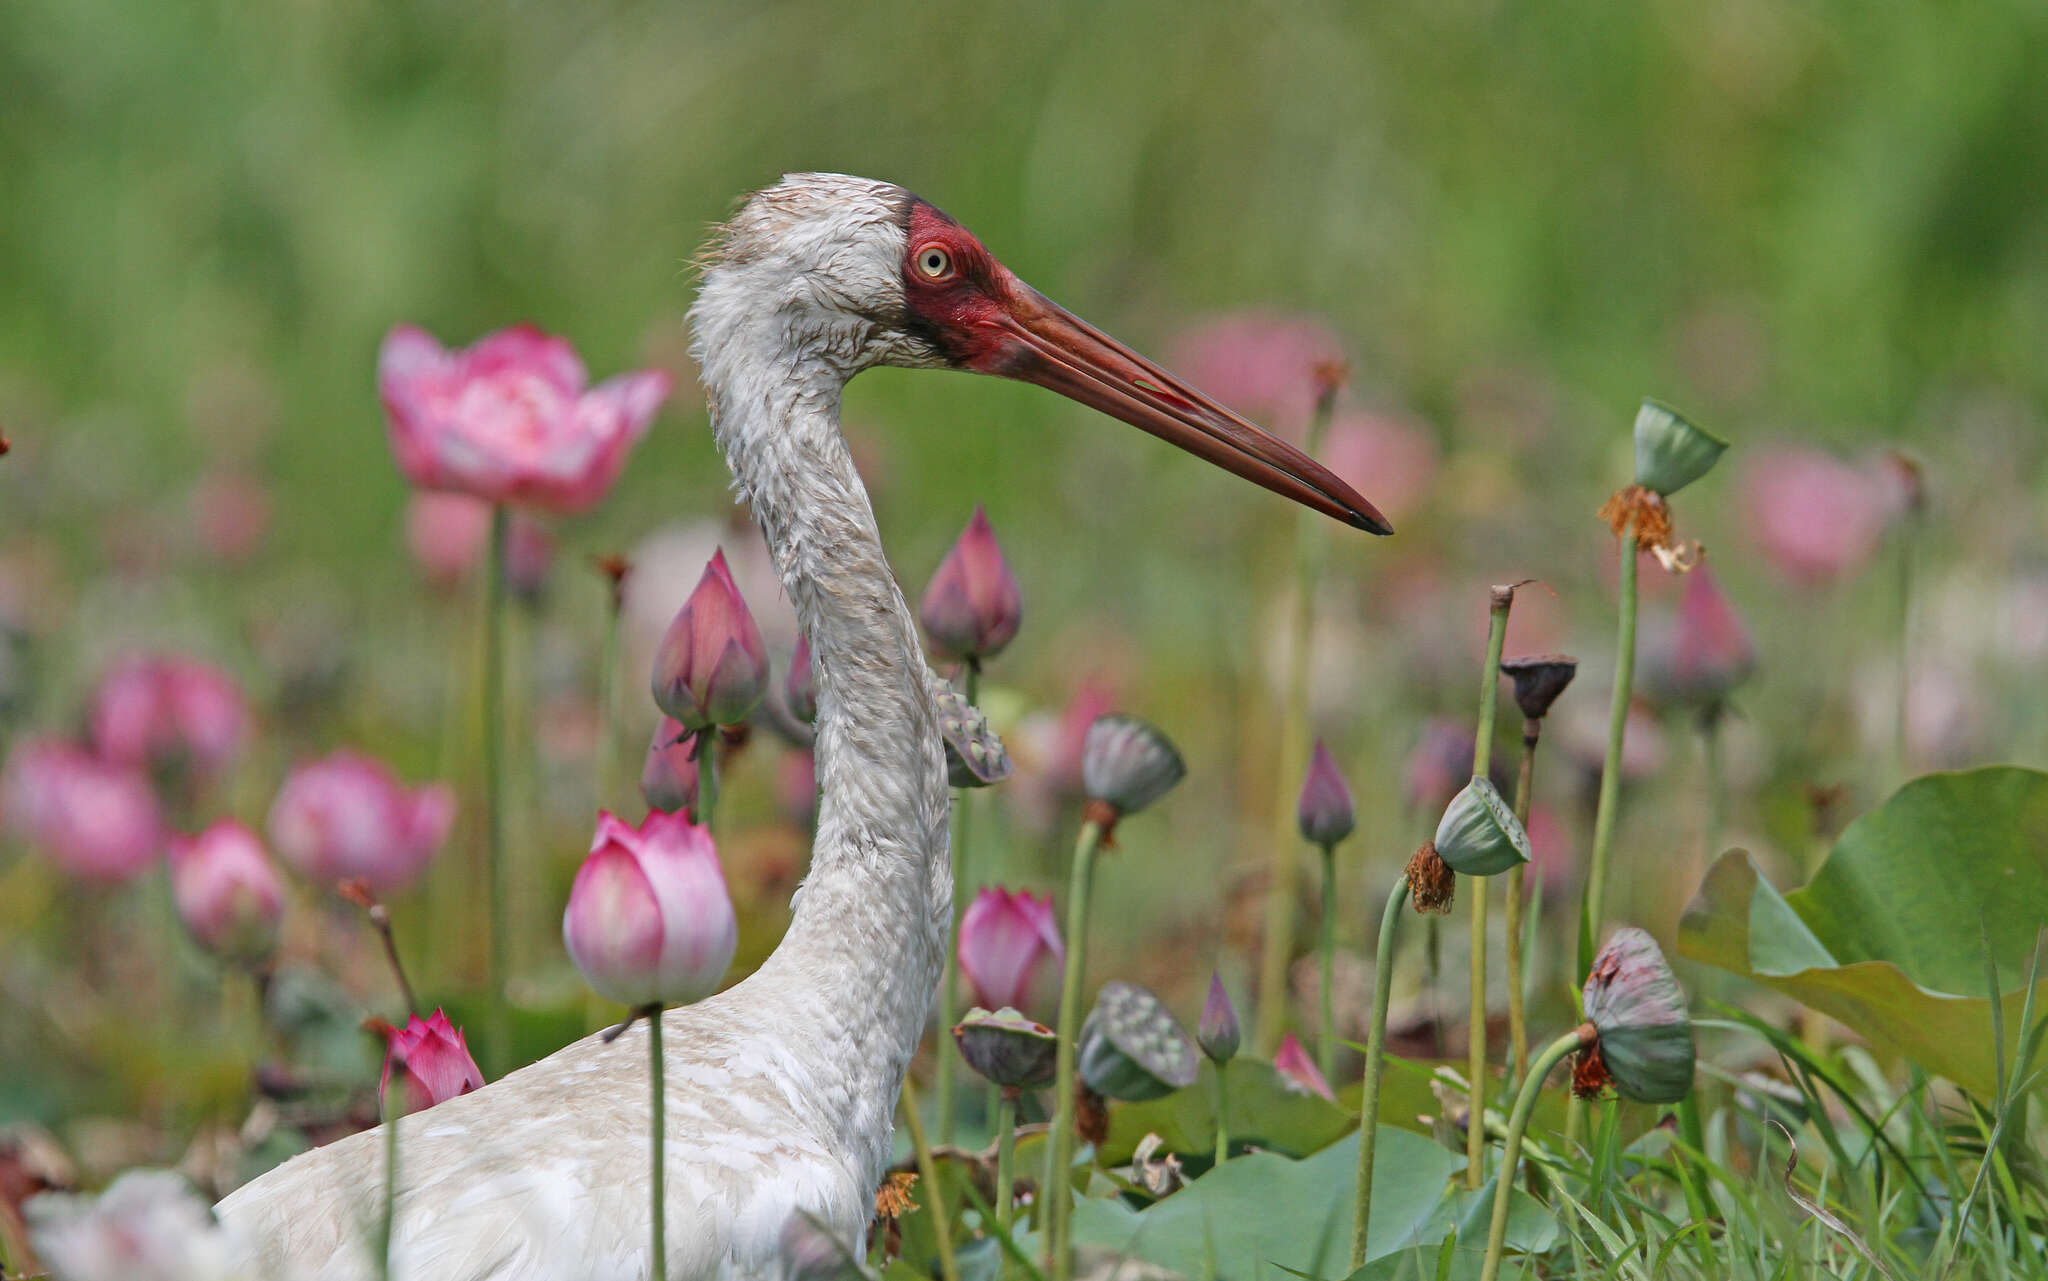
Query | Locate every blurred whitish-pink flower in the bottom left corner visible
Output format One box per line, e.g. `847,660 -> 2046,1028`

23,1170 -> 260,1281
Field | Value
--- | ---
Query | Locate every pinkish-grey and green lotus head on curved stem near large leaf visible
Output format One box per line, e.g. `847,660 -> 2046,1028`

1581,926 -> 1694,1103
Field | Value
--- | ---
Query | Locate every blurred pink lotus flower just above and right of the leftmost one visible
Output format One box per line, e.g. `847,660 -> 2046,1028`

92,654 -> 250,775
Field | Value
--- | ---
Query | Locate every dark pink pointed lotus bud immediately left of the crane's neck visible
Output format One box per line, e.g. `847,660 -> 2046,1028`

653,547 -> 768,730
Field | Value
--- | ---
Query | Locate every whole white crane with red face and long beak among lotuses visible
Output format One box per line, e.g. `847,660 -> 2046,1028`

219,174 -> 1389,1281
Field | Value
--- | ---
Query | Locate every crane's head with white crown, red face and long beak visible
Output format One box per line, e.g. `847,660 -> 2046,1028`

690,174 -> 1393,533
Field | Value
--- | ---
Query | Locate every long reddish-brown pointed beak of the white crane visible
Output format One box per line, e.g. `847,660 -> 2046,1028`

989,283 -> 1395,533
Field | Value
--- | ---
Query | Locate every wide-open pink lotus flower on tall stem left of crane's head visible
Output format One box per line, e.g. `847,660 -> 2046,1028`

377,324 -> 670,514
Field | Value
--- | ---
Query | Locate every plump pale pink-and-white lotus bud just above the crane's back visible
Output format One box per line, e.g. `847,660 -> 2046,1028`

561,812 -> 739,1008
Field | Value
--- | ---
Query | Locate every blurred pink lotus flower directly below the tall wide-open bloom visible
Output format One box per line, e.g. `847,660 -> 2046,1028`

270,750 -> 455,894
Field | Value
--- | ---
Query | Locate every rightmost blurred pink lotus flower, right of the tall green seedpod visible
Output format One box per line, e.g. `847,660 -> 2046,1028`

1743,438 -> 1896,584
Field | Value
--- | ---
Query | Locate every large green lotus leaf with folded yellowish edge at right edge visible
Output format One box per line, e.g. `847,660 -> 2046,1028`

1677,767 -> 2048,1094
